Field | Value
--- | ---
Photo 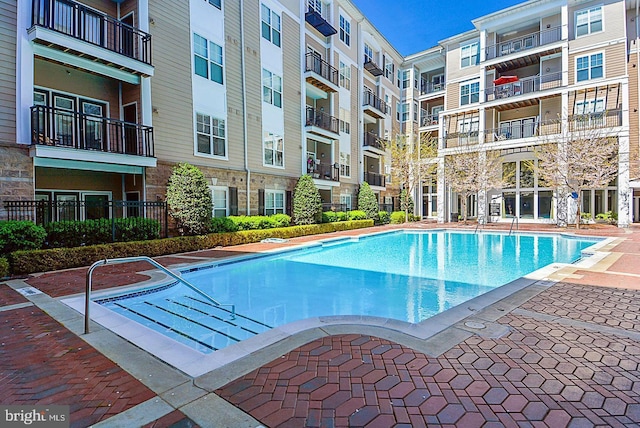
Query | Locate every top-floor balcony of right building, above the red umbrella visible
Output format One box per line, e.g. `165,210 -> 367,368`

485,27 -> 562,72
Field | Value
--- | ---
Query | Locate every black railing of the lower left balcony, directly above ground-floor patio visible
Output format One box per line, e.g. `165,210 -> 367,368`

31,106 -> 154,157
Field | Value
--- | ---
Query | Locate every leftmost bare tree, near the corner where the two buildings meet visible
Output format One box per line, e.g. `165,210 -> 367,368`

385,134 -> 438,221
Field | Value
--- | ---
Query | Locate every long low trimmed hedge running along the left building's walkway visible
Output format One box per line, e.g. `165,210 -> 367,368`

9,220 -> 373,275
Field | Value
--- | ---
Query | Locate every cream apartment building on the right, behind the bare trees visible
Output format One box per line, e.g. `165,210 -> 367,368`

403,0 -> 640,226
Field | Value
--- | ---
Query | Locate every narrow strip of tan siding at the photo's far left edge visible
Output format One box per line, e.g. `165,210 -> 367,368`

0,0 -> 17,143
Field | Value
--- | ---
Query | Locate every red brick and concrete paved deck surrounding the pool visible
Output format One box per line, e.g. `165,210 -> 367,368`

0,223 -> 640,427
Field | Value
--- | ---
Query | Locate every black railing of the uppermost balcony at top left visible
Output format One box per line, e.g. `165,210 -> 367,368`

31,0 -> 151,65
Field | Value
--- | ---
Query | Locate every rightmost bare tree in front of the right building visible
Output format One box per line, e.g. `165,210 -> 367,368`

535,112 -> 618,229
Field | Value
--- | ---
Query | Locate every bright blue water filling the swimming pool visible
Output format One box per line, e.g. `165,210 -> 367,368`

99,231 -> 597,352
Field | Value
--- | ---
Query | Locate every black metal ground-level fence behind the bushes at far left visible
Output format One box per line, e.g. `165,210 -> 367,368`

4,200 -> 168,242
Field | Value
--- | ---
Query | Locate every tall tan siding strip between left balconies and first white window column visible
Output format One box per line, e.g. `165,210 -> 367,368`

149,1 -> 194,162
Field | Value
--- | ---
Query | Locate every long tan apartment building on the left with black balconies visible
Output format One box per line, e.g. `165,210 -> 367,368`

0,0 -> 403,220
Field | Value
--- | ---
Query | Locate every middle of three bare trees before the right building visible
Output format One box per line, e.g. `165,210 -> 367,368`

444,146 -> 509,224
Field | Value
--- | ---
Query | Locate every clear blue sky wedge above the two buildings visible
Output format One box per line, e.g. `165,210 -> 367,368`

351,0 -> 524,56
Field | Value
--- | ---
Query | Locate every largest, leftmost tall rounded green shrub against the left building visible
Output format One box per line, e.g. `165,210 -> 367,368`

167,163 -> 213,235
